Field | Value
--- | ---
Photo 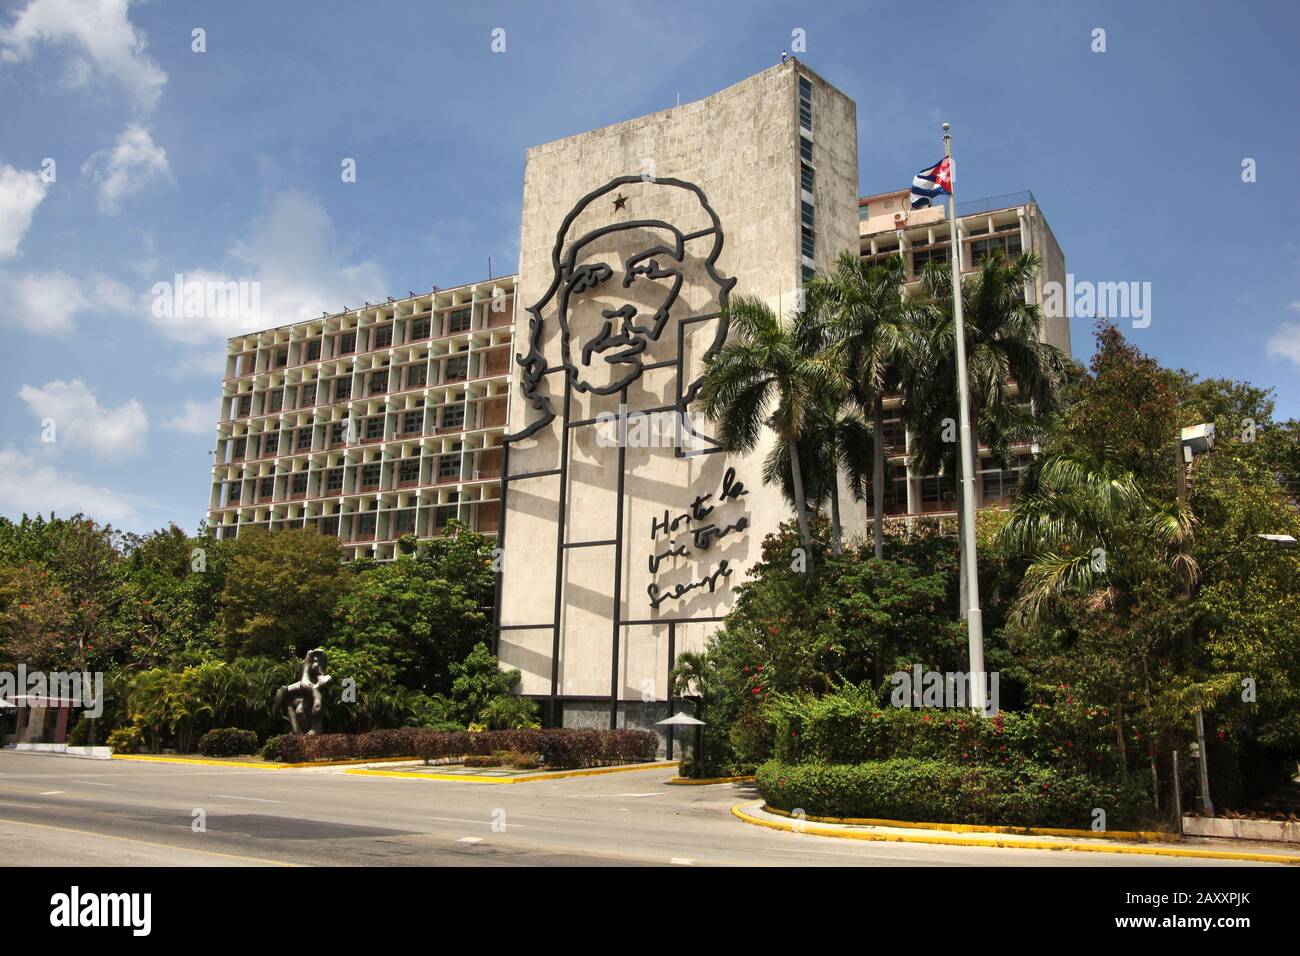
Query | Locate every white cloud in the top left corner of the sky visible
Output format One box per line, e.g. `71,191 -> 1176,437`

0,0 -> 166,112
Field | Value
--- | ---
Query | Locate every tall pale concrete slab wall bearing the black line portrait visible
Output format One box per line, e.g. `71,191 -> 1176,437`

498,60 -> 857,726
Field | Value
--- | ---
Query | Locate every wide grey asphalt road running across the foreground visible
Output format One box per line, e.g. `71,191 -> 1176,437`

0,752 -> 1268,868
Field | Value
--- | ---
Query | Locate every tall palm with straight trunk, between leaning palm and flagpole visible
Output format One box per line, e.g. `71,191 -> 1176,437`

807,250 -> 915,558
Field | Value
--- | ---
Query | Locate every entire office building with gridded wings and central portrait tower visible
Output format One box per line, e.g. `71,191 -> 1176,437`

209,60 -> 1069,726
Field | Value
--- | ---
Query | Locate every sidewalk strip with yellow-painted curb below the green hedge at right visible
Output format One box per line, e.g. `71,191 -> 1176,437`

732,800 -> 1300,866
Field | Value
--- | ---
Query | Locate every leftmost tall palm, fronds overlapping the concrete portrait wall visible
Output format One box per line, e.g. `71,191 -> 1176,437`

699,295 -> 842,554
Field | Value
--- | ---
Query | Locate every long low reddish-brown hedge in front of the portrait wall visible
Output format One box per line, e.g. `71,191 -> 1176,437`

263,727 -> 659,770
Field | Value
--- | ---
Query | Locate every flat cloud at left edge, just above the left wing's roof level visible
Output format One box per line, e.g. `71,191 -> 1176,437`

0,271 -> 139,336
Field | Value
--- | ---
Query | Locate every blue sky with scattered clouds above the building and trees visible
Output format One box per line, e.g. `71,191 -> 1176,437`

0,0 -> 1300,531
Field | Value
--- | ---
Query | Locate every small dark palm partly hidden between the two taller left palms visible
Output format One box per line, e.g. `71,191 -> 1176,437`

763,398 -> 875,554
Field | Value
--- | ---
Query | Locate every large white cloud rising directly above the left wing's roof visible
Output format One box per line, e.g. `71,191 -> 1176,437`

150,190 -> 386,345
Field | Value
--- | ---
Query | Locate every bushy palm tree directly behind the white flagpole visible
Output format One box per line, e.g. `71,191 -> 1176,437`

906,252 -> 1069,614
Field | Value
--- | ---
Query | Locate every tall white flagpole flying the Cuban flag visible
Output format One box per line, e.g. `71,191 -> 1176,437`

944,122 -> 988,714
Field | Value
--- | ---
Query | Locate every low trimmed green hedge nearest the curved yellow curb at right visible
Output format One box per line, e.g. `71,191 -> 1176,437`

757,757 -> 1147,829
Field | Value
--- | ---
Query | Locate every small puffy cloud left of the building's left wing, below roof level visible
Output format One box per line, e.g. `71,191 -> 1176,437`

18,378 -> 150,458
